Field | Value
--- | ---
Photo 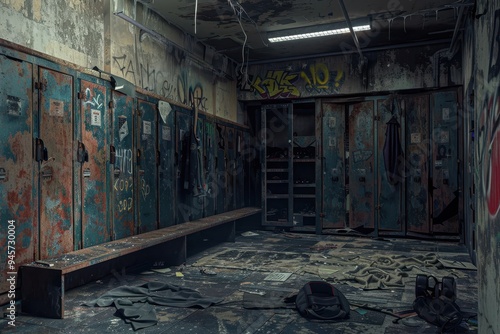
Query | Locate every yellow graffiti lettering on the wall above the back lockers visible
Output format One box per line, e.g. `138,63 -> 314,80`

238,63 -> 345,99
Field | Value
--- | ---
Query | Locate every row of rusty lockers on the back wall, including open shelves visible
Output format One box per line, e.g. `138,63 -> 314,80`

261,87 -> 467,238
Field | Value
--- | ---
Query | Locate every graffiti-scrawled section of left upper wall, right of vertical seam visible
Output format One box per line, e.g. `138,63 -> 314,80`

110,0 -> 233,121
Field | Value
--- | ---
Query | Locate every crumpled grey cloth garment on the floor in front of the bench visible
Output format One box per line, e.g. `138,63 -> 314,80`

83,282 -> 223,330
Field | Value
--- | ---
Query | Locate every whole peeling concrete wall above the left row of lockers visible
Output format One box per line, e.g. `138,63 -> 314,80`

0,0 -> 237,121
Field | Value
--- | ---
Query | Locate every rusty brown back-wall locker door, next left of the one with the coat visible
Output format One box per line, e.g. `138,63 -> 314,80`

346,101 -> 375,229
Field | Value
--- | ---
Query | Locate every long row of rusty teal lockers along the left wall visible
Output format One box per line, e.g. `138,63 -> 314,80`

0,49 -> 249,293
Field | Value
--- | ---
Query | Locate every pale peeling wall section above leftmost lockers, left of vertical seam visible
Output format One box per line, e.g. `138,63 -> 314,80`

0,0 -> 106,68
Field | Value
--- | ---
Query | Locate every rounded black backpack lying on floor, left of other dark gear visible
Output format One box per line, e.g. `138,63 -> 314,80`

295,281 -> 350,320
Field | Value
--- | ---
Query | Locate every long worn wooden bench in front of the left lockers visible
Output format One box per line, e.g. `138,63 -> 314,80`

19,207 -> 262,319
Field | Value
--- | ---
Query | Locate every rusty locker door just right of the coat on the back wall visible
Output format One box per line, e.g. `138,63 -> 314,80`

405,94 -> 430,234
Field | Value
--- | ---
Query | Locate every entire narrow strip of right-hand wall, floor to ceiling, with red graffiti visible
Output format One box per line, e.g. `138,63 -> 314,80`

474,0 -> 500,333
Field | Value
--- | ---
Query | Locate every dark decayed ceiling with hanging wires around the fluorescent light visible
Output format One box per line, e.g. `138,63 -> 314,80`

142,0 -> 474,63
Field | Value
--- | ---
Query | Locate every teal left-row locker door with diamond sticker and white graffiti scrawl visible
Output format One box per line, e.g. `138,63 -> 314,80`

111,91 -> 137,240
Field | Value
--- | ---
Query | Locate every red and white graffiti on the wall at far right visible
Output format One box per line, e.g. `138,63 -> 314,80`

479,10 -> 500,217
